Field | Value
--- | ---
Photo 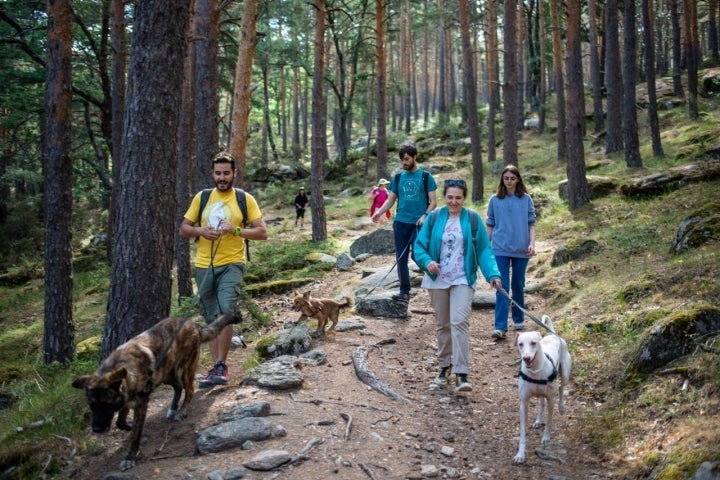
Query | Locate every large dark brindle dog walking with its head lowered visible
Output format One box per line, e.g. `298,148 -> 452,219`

72,314 -> 242,471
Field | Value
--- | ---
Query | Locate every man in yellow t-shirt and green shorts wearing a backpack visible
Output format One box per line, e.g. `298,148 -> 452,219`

180,152 -> 267,388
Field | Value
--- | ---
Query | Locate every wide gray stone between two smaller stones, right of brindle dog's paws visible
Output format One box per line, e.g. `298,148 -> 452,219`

195,417 -> 270,455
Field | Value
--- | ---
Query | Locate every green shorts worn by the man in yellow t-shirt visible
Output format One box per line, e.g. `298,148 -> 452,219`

195,263 -> 245,323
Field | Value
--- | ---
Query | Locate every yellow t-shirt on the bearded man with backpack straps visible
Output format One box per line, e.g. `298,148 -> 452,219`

185,188 -> 262,268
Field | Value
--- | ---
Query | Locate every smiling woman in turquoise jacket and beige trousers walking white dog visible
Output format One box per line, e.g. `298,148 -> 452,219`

413,180 -> 501,392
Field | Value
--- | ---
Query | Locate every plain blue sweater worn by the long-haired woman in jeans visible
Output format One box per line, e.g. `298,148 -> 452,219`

485,194 -> 535,258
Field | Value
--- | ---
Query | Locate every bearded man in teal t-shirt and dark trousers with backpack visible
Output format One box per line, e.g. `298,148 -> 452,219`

372,145 -> 437,302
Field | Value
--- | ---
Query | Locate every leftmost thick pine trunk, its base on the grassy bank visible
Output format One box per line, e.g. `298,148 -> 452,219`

43,0 -> 75,364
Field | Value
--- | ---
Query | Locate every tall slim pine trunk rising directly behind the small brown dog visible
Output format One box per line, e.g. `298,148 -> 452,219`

310,0 -> 327,242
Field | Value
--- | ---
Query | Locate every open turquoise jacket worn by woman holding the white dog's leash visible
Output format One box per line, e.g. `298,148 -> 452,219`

413,207 -> 501,286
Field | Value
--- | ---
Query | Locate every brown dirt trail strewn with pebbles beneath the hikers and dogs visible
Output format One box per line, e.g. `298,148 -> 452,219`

63,251 -> 612,480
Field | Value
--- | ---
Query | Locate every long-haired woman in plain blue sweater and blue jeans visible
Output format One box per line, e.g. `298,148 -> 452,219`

485,165 -> 535,340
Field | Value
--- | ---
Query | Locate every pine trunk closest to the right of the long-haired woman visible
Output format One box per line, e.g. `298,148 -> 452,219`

565,2 -> 590,210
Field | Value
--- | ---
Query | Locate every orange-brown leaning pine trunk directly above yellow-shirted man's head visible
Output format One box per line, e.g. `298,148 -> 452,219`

230,0 -> 258,187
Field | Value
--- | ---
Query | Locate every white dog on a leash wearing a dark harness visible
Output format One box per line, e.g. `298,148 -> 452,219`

513,315 -> 572,464
